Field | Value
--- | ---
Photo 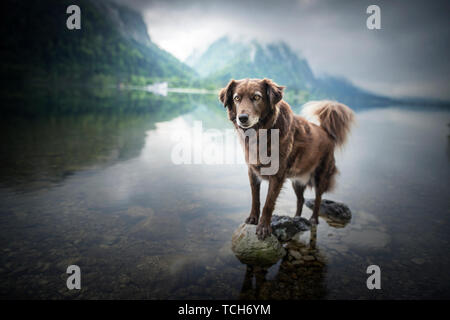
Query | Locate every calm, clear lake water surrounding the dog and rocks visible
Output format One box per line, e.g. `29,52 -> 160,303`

0,88 -> 450,299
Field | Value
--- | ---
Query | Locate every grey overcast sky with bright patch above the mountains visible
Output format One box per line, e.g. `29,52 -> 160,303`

118,0 -> 450,99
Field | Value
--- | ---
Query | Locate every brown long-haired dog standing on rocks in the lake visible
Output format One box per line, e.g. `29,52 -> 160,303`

219,79 -> 354,239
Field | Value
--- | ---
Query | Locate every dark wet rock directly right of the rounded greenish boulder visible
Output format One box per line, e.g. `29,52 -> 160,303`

270,215 -> 311,241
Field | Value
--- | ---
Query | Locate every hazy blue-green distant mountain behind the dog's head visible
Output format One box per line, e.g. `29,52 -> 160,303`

186,36 -> 393,108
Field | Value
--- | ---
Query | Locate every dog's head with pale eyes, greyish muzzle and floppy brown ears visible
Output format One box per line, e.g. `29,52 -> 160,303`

219,79 -> 284,129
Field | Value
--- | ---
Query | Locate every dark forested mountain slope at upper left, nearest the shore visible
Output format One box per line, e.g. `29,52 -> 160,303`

0,0 -> 195,86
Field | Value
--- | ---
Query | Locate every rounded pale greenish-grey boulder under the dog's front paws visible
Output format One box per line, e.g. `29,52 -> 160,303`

231,223 -> 286,266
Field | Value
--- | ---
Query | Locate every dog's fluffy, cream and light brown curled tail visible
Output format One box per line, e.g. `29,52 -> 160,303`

302,100 -> 355,146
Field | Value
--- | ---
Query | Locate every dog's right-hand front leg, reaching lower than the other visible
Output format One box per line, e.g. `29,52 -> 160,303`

256,176 -> 284,240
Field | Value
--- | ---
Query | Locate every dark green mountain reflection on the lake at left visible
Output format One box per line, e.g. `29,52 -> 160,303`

0,88 -> 204,190
